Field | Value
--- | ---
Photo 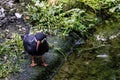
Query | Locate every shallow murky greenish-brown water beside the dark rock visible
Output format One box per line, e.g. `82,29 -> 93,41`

53,20 -> 120,80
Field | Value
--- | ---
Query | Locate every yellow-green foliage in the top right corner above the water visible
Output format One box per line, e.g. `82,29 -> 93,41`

79,0 -> 120,19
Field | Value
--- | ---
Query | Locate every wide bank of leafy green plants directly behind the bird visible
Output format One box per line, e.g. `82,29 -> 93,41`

27,0 -> 97,36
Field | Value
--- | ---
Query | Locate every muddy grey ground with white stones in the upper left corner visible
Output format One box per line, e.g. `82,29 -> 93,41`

0,0 -> 30,42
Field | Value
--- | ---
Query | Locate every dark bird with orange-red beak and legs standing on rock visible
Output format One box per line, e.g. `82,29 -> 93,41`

21,27 -> 49,67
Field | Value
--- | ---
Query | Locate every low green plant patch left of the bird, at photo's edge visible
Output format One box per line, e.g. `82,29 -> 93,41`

0,34 -> 23,78
